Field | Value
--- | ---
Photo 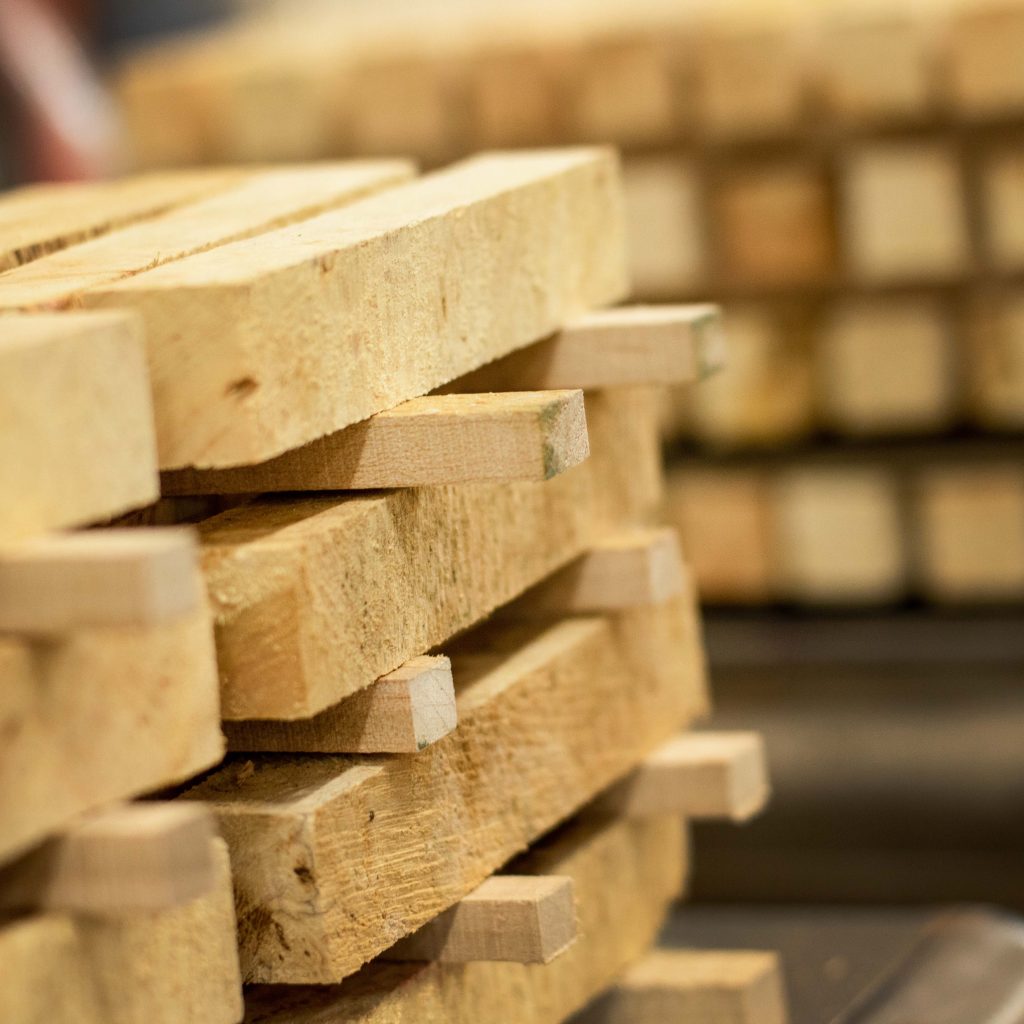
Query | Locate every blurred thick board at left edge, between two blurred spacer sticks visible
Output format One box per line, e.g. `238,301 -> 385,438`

0,606 -> 224,860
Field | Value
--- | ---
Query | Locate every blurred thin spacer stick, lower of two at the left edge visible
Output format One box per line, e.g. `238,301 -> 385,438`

0,802 -> 216,916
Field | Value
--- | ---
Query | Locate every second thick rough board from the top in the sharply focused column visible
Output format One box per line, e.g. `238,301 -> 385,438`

200,389 -> 660,720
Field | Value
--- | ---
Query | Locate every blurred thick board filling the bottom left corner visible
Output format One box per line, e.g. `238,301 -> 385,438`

0,840 -> 244,1024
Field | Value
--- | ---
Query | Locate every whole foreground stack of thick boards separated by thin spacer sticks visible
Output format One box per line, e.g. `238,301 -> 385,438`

0,148 -> 784,1024
